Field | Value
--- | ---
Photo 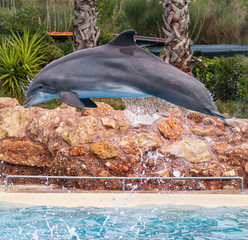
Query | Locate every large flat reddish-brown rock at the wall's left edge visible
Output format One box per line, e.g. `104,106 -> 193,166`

0,140 -> 51,167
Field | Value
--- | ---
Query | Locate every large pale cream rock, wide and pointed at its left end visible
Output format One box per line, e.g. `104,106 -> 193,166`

162,139 -> 211,163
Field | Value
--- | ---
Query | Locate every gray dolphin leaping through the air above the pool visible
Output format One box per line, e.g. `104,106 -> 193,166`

24,30 -> 225,119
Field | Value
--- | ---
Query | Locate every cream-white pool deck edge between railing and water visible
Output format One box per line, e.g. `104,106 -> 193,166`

0,187 -> 248,208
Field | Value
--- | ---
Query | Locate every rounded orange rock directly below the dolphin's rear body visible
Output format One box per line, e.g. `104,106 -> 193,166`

158,118 -> 182,140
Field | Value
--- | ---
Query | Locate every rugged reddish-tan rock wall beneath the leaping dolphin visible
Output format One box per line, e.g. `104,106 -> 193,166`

0,98 -> 248,190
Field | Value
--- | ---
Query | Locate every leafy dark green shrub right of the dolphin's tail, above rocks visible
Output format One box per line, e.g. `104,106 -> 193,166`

193,55 -> 248,101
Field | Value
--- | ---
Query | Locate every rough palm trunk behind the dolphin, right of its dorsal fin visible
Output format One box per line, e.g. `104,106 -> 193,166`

162,0 -> 193,73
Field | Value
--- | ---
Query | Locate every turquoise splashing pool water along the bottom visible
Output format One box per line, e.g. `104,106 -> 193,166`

0,204 -> 248,240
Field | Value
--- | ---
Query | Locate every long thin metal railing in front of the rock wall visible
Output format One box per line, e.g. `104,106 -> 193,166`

5,175 -> 244,193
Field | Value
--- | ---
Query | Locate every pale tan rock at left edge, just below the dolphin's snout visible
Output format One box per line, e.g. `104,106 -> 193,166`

0,106 -> 29,138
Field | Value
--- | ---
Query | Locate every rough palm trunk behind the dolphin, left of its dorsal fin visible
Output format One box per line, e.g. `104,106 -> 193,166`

73,0 -> 100,51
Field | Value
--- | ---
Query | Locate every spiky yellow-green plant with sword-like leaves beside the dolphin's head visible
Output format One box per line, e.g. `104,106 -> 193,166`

0,31 -> 47,97
